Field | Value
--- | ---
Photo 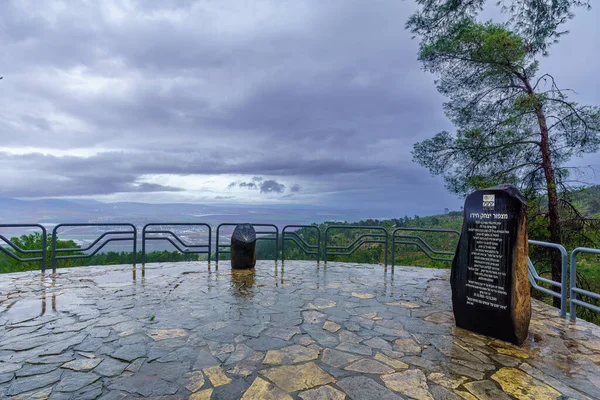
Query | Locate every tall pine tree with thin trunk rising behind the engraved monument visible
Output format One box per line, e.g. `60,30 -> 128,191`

407,0 -> 600,302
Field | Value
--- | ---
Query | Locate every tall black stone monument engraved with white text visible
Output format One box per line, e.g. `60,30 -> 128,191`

450,186 -> 531,345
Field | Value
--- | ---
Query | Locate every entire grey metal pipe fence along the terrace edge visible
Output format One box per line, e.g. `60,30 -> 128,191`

0,222 -> 600,320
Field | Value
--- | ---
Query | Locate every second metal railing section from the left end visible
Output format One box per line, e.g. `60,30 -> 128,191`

52,223 -> 137,272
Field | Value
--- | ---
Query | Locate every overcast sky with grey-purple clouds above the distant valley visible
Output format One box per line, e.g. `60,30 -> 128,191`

0,0 -> 600,215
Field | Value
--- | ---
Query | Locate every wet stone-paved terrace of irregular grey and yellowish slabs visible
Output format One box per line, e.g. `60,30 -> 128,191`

0,261 -> 600,400
